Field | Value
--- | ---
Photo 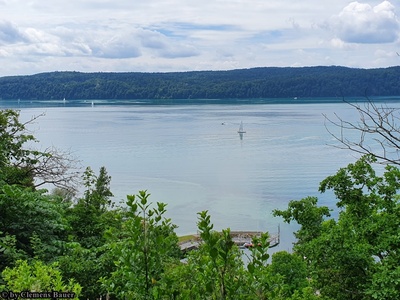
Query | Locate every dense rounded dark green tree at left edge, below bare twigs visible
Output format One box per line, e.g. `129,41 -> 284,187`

0,184 -> 68,269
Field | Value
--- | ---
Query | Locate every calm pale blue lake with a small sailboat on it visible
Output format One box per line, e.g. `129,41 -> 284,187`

0,98 -> 399,250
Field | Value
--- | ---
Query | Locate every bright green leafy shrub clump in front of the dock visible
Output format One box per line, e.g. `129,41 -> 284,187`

158,211 -> 290,300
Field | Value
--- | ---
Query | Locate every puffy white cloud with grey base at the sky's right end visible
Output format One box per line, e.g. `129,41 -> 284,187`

333,1 -> 400,44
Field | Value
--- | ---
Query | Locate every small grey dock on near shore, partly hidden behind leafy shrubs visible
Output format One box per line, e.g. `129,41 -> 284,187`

179,227 -> 280,252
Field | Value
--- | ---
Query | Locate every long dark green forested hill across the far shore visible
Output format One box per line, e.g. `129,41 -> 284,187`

0,66 -> 400,100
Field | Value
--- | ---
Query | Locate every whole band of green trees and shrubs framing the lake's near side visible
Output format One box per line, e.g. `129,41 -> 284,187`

0,103 -> 400,300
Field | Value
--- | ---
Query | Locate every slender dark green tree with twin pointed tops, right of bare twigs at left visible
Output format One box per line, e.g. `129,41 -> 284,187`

58,167 -> 119,299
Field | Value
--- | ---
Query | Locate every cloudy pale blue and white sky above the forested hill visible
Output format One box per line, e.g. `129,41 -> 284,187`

0,0 -> 400,76
